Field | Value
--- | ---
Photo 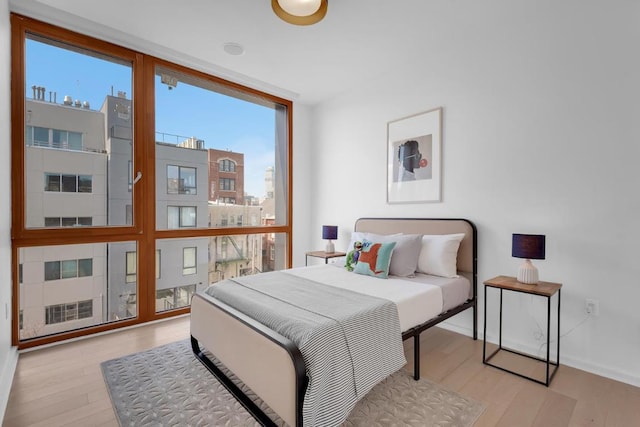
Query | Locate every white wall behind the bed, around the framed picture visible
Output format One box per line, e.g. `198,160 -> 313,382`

310,0 -> 640,385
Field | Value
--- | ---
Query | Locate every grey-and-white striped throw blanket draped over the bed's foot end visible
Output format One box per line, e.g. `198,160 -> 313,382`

205,271 -> 406,426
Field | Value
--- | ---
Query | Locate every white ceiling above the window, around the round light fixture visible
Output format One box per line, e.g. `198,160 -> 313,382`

10,0 -> 449,105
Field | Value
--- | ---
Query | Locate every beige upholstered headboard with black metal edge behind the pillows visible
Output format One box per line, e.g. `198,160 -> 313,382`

354,218 -> 478,282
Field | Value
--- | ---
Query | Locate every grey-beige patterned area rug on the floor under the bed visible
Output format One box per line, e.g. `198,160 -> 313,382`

101,340 -> 484,427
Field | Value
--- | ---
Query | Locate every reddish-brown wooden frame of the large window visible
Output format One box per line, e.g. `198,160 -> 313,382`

10,13 -> 293,349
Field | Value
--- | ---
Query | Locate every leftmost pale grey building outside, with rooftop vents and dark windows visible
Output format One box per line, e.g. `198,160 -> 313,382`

18,95 -> 109,338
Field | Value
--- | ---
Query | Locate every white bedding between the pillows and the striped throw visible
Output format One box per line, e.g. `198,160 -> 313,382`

287,264 -> 469,332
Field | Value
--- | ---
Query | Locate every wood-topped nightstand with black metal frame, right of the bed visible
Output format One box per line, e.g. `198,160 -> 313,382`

482,276 -> 562,387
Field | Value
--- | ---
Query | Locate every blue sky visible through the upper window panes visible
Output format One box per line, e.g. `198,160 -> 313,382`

25,40 -> 275,197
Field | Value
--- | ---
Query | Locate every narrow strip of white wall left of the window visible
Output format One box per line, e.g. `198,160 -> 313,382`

0,0 -> 18,420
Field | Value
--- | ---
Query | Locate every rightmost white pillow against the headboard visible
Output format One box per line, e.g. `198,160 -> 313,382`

418,233 -> 464,278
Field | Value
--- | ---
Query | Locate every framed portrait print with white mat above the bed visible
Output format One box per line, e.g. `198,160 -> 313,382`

387,107 -> 442,204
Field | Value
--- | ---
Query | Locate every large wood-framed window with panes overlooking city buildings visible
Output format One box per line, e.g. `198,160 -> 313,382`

12,15 -> 291,347
